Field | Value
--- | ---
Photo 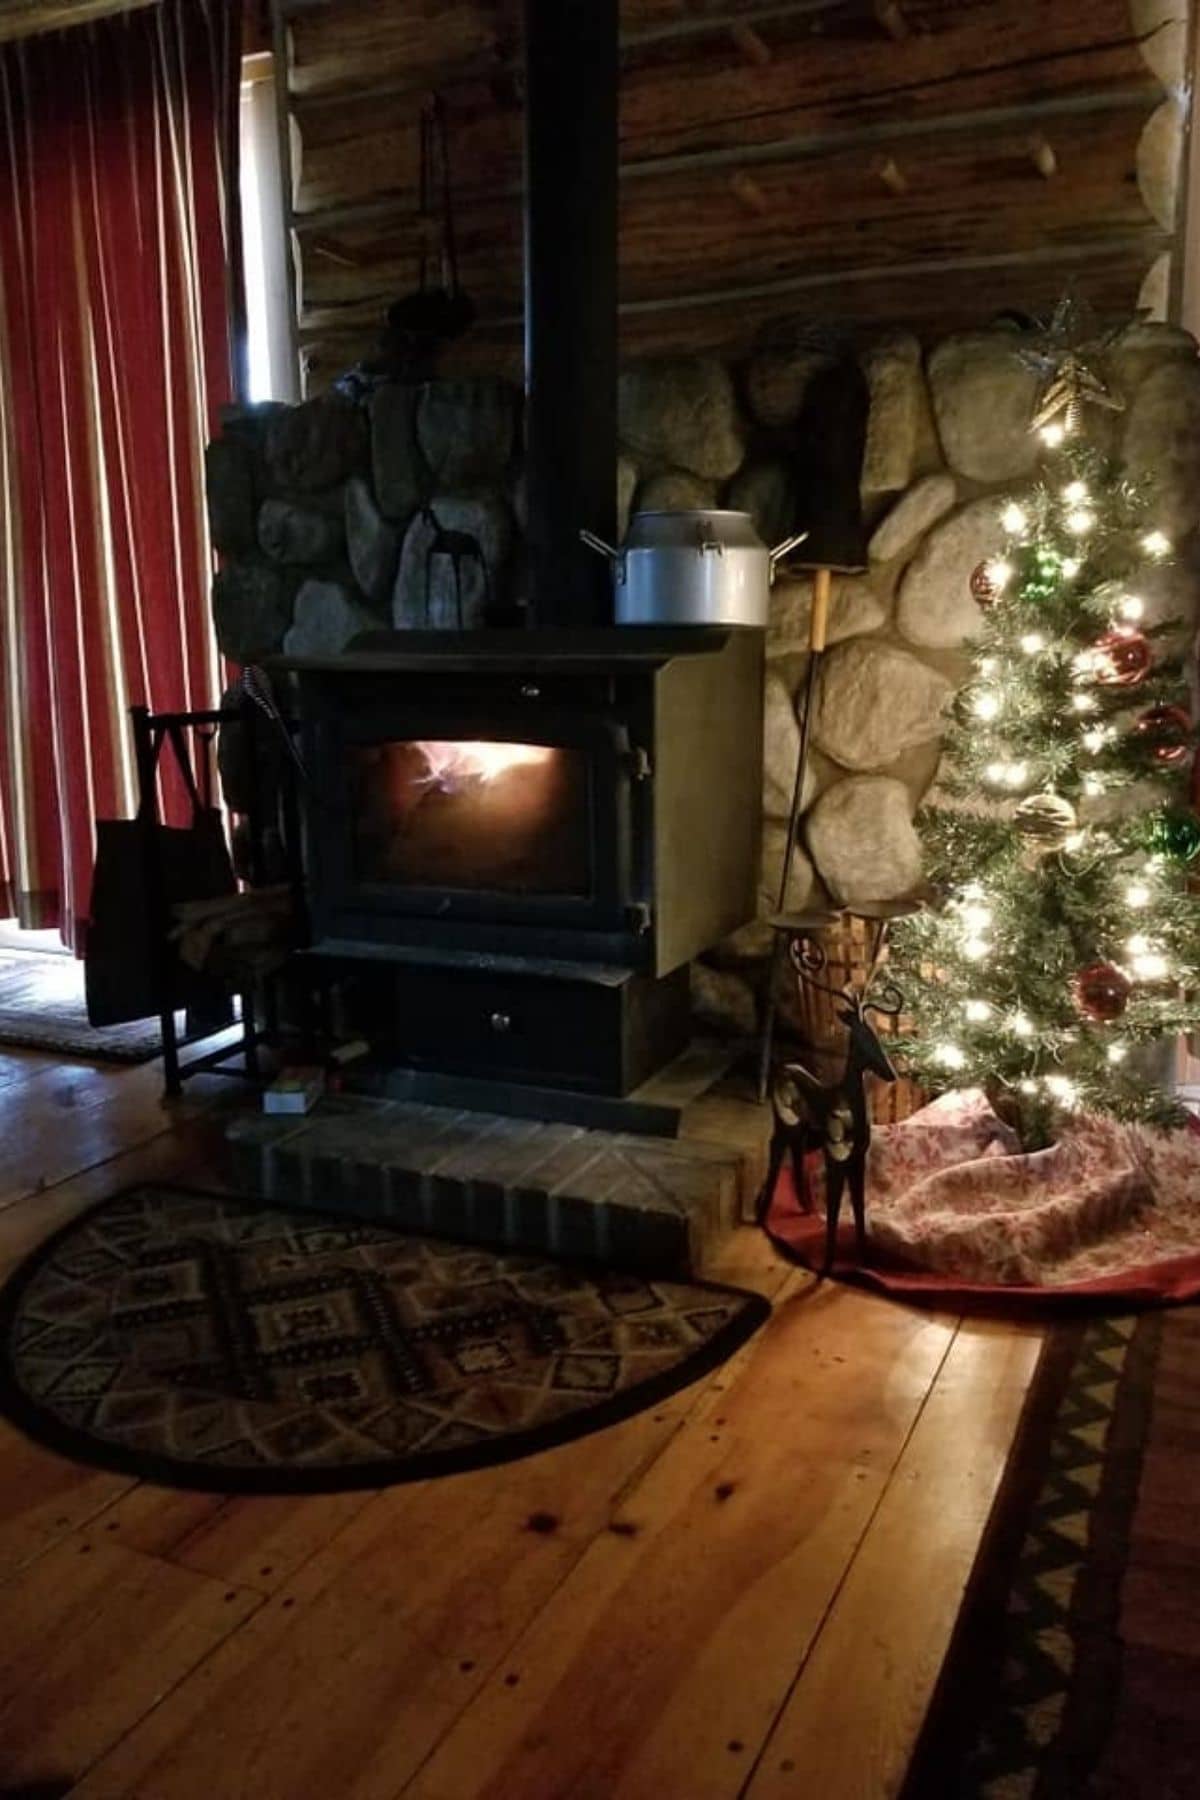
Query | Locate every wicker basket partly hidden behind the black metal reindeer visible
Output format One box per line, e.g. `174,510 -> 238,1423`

777,914 -> 925,1125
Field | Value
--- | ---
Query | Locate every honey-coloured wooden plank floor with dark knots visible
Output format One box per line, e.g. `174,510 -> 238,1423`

0,1053 -> 1038,1800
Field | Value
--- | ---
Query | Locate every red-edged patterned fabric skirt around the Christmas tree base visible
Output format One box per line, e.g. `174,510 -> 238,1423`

766,1089 -> 1200,1303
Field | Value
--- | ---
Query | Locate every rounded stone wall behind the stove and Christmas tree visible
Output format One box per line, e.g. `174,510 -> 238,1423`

209,322 -> 1200,1031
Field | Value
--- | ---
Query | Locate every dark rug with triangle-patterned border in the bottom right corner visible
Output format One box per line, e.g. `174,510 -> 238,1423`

905,1307 -> 1200,1800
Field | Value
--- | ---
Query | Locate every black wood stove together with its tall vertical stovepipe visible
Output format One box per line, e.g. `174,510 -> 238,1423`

264,0 -> 763,1129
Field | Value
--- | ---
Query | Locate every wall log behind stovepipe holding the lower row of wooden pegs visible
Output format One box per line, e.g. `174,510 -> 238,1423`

299,100 -> 1151,306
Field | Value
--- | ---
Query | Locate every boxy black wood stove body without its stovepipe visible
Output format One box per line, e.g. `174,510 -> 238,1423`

275,628 -> 763,1111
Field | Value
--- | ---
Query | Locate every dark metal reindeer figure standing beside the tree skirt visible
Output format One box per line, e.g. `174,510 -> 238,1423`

757,922 -> 903,1274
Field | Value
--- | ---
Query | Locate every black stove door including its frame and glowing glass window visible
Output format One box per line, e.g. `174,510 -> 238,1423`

306,700 -> 644,949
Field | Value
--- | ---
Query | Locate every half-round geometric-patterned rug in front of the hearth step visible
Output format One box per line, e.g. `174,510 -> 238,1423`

0,1186 -> 770,1492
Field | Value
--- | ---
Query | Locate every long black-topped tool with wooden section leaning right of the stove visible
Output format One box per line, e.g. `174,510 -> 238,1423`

759,351 -> 871,1102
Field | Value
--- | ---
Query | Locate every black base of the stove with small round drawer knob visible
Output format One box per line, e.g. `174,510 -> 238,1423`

360,965 -> 689,1094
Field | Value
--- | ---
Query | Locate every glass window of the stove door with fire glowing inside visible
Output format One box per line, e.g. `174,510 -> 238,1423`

351,738 -> 592,896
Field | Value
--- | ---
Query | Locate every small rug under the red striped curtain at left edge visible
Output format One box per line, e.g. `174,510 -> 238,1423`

0,950 -> 162,1062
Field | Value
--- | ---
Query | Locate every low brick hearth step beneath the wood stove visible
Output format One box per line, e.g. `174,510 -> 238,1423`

227,1096 -> 747,1274
